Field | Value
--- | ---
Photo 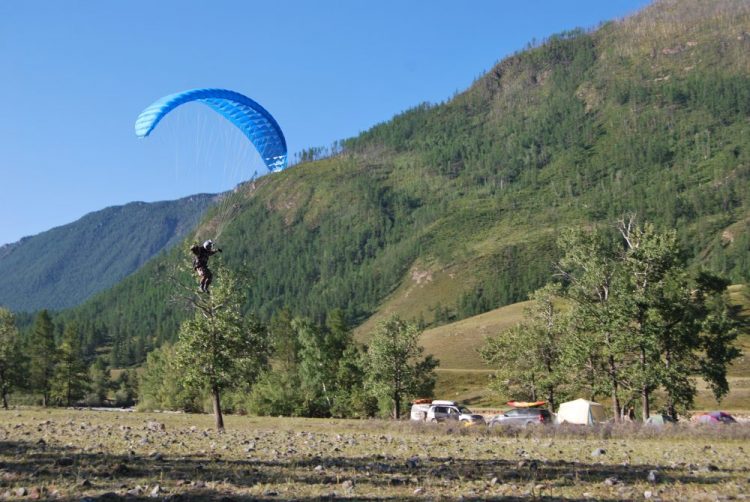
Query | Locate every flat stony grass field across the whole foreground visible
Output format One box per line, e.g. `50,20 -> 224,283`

0,409 -> 750,500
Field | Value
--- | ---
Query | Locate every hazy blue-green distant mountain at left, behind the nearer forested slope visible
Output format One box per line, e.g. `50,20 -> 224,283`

0,194 -> 216,311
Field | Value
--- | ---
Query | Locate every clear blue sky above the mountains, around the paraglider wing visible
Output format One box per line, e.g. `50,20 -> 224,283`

0,0 -> 650,245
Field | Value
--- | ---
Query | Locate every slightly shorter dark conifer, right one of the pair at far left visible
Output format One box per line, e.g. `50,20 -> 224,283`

50,323 -> 88,406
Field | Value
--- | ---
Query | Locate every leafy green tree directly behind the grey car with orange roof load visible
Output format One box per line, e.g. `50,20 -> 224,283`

480,283 -> 568,411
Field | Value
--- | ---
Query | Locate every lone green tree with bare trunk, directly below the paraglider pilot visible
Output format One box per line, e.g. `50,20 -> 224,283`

177,265 -> 269,431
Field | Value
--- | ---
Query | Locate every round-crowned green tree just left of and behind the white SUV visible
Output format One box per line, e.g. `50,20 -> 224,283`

367,316 -> 438,419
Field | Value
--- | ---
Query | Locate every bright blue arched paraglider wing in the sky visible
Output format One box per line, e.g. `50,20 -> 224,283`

135,89 -> 287,175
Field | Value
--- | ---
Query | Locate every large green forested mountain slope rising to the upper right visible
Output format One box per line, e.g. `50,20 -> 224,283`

55,0 -> 750,364
